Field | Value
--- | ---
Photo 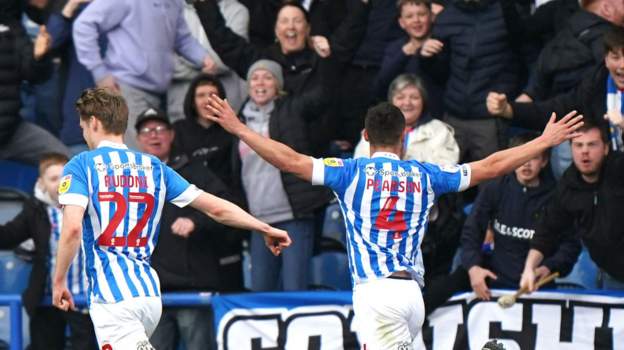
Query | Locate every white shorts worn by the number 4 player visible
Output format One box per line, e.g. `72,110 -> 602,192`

353,278 -> 425,350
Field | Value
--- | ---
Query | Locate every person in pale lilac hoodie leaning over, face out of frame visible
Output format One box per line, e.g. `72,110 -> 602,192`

73,0 -> 215,149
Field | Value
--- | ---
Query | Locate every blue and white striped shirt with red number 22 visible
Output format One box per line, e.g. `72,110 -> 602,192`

59,141 -> 201,304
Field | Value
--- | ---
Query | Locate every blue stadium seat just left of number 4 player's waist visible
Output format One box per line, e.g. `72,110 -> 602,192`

310,237 -> 351,290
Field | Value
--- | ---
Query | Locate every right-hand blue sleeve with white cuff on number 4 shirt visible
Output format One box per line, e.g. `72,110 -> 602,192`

422,163 -> 471,196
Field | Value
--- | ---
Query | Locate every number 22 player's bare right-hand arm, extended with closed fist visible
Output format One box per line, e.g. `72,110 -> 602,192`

191,192 -> 291,255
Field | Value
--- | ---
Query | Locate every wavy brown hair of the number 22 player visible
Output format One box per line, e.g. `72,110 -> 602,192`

76,88 -> 128,135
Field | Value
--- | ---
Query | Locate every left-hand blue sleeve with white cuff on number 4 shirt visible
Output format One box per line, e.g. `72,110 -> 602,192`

312,158 -> 356,192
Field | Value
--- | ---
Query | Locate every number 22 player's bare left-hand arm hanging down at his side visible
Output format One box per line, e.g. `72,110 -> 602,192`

52,205 -> 85,311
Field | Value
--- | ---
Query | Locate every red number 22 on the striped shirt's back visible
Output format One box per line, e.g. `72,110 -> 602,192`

98,192 -> 154,247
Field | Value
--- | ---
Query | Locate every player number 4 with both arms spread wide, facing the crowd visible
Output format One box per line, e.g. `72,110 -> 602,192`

209,95 -> 583,350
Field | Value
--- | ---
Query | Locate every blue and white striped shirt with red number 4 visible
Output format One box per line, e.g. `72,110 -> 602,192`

312,152 -> 470,286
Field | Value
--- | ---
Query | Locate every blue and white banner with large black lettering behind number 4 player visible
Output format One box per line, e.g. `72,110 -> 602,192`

213,290 -> 624,350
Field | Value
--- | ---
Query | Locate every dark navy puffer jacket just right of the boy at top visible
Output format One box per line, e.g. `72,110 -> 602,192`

423,0 -> 522,119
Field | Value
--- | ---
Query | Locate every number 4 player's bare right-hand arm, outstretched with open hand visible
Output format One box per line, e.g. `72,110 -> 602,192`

470,111 -> 583,186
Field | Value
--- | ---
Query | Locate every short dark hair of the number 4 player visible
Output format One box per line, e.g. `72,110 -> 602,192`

364,102 -> 405,146
